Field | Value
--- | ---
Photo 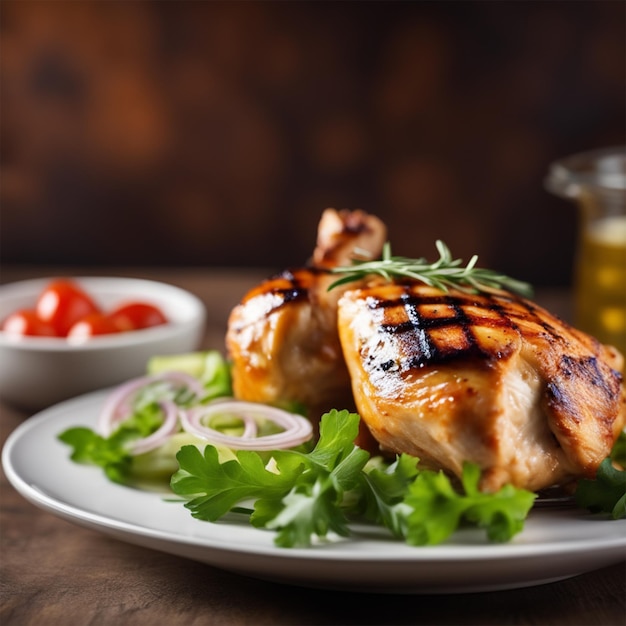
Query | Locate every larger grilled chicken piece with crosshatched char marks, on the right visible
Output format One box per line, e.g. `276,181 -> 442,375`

338,282 -> 625,491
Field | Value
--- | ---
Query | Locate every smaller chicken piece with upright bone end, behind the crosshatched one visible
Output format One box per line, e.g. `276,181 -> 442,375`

226,209 -> 386,422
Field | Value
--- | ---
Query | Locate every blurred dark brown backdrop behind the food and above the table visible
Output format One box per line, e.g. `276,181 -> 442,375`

0,0 -> 626,285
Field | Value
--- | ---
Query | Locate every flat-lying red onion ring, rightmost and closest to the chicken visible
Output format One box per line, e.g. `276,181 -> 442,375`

179,400 -> 313,450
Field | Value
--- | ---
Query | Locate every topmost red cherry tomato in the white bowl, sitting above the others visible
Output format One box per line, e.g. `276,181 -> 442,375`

35,280 -> 100,337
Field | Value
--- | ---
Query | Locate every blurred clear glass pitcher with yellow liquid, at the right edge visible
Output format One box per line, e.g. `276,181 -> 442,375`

546,147 -> 626,356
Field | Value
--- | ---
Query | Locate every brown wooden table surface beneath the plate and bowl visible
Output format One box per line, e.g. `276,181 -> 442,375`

0,267 -> 626,626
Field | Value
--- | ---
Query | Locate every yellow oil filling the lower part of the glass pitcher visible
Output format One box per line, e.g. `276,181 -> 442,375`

574,215 -> 626,356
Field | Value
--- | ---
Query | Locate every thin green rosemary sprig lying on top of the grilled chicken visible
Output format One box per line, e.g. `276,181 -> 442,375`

328,240 -> 533,297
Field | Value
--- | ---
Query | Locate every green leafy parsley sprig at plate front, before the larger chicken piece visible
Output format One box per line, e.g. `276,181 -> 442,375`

171,410 -> 535,547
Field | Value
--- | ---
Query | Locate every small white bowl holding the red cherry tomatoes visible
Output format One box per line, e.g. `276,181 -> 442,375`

0,277 -> 206,411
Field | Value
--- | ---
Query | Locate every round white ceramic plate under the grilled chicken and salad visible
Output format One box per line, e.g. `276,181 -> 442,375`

2,391 -> 626,593
